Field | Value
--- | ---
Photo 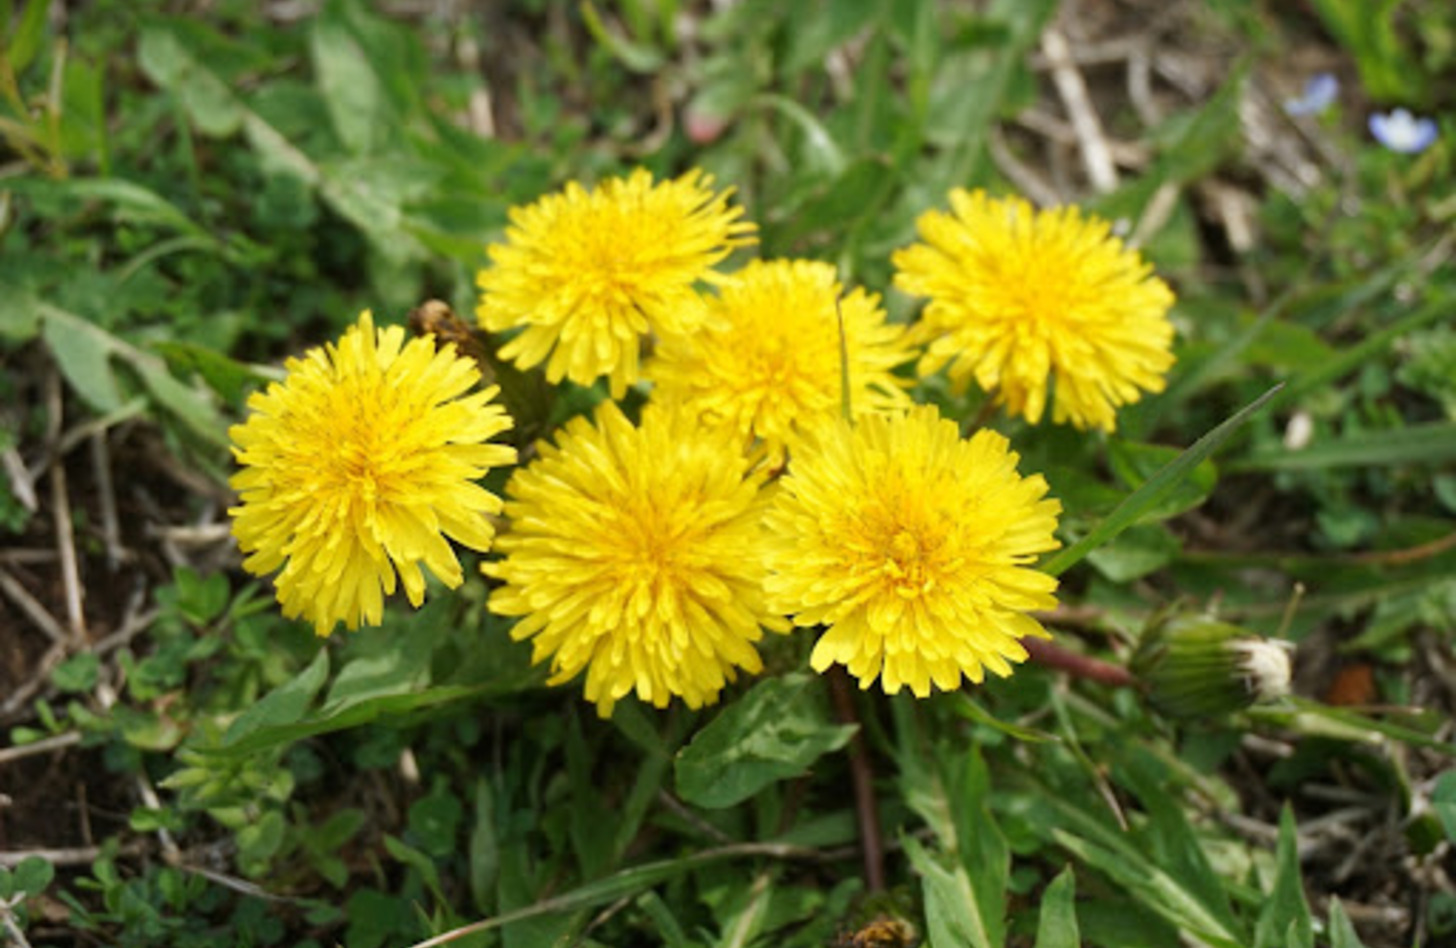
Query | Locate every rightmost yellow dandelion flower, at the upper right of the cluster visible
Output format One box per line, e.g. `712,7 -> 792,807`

891,188 -> 1174,431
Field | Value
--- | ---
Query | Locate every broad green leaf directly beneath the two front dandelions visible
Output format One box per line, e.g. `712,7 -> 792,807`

674,674 -> 855,808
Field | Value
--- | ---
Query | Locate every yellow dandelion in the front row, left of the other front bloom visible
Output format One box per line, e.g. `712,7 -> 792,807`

480,402 -> 788,718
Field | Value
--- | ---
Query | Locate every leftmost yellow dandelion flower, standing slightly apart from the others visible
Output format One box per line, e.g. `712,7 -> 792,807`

227,312 -> 515,635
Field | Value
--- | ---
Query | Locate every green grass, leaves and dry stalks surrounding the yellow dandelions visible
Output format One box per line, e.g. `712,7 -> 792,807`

0,0 -> 1456,948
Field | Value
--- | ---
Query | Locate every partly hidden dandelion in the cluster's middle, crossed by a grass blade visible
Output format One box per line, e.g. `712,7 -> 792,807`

646,261 -> 913,451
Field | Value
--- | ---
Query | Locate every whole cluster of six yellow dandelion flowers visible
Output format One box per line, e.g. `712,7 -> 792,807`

230,170 -> 1172,716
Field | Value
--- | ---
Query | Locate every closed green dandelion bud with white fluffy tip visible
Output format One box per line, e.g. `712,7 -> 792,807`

1131,616 -> 1290,718
